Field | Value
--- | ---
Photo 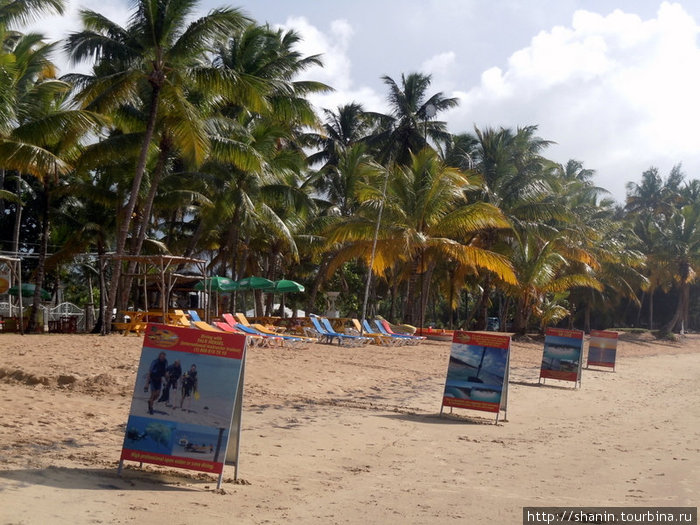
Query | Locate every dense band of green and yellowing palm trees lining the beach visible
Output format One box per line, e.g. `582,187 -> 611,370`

0,0 -> 700,333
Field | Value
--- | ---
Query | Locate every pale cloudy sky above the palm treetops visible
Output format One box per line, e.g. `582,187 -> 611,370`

24,0 -> 700,202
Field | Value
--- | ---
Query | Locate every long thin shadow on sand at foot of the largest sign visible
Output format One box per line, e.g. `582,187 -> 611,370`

0,465 -> 208,492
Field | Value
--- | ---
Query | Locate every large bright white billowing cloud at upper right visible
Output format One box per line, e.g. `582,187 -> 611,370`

448,2 -> 700,200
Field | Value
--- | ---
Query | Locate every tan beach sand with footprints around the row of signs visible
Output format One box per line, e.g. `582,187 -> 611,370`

0,334 -> 700,525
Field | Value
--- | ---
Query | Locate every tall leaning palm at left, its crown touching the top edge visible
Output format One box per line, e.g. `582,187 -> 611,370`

66,0 -> 249,324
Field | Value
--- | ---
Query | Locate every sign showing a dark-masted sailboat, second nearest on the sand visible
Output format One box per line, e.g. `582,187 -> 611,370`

440,331 -> 510,423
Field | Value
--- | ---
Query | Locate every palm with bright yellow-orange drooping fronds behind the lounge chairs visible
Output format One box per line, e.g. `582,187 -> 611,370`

327,148 -> 515,323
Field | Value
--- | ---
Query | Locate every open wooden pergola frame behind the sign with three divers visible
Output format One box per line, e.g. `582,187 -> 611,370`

100,253 -> 211,335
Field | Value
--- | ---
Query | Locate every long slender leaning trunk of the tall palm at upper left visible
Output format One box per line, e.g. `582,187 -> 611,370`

107,83 -> 161,328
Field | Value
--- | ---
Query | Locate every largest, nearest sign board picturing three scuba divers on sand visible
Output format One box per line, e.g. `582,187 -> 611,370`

119,324 -> 246,484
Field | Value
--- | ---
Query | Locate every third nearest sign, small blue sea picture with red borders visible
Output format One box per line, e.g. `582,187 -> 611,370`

540,328 -> 583,383
